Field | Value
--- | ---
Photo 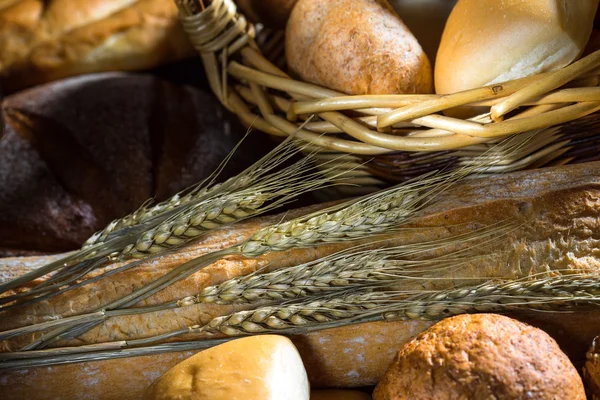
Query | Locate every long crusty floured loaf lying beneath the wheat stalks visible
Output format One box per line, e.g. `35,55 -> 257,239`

0,163 -> 600,399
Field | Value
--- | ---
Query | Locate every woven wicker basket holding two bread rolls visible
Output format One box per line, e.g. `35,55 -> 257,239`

177,0 -> 600,191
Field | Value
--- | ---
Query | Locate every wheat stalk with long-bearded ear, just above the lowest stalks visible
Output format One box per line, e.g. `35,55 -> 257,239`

0,222 -> 516,340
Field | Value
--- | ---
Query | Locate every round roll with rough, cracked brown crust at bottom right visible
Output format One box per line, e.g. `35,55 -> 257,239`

373,314 -> 585,400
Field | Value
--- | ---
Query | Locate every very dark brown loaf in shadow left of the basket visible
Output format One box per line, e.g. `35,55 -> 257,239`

0,73 -> 268,256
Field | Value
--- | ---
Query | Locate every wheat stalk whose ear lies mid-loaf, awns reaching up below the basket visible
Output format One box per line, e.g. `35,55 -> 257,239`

16,132 -> 536,350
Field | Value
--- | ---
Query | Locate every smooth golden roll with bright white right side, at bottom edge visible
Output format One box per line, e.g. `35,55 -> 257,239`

144,335 -> 310,400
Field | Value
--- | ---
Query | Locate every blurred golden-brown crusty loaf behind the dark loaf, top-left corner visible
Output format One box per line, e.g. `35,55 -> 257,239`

0,0 -> 194,91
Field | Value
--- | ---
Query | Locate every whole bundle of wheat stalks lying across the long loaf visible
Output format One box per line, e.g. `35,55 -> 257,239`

0,133 -> 600,370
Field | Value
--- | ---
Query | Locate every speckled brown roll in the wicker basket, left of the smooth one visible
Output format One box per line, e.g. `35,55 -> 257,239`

285,0 -> 433,94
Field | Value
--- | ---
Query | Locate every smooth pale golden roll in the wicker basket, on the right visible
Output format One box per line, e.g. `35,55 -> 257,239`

435,0 -> 598,93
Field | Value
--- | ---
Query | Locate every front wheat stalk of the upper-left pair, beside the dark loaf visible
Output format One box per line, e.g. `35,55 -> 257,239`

0,129 -> 344,309
